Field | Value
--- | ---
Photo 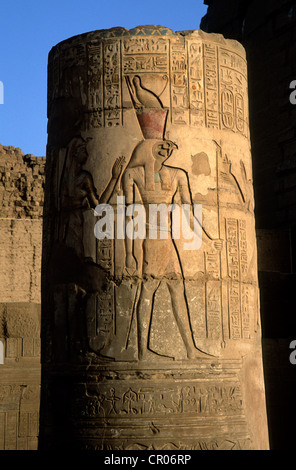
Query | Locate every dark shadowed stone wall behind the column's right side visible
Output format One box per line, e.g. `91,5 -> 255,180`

201,0 -> 296,449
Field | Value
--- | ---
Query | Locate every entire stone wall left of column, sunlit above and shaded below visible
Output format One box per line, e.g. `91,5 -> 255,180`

0,145 -> 45,450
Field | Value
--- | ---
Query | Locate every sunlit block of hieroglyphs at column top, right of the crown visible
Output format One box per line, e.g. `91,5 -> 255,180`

170,41 -> 247,133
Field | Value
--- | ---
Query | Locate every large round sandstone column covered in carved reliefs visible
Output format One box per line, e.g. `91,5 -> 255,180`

40,26 -> 268,450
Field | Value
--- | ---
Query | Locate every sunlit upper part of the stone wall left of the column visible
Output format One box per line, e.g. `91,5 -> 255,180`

0,145 -> 45,304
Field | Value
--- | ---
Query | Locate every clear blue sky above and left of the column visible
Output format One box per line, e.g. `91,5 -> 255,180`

0,0 -> 207,156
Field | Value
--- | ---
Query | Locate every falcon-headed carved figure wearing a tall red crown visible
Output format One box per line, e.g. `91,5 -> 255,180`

122,76 -> 222,360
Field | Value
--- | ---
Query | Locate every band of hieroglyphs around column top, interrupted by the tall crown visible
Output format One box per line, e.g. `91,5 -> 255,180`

48,36 -> 247,134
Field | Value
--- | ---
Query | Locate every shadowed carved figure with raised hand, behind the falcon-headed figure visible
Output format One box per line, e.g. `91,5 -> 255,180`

53,136 -> 123,357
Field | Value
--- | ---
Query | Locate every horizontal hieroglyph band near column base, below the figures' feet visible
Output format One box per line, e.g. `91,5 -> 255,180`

85,383 -> 243,417
